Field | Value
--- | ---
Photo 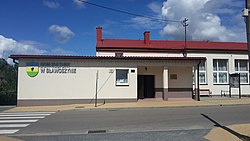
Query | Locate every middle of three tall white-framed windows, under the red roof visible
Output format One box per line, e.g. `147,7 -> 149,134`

213,59 -> 228,84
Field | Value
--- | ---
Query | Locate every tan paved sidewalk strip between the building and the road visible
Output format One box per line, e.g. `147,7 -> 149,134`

5,97 -> 250,112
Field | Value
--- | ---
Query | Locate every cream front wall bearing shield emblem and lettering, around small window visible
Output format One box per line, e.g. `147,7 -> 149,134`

18,59 -> 137,100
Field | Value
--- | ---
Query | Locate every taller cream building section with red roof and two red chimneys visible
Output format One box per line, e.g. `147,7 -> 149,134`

96,27 -> 250,96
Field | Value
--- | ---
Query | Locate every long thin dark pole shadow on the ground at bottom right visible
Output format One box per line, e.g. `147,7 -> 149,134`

201,113 -> 250,141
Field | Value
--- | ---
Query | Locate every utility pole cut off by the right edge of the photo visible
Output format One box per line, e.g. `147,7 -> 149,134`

243,0 -> 250,72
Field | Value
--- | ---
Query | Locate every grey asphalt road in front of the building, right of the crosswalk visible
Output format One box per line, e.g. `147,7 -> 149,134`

8,105 -> 250,141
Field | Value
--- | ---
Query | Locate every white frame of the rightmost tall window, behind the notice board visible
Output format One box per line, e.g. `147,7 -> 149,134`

234,59 -> 249,84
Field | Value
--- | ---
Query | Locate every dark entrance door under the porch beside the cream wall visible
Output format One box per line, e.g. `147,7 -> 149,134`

137,75 -> 155,99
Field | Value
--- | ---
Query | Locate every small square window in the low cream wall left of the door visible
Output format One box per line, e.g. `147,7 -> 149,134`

116,69 -> 129,85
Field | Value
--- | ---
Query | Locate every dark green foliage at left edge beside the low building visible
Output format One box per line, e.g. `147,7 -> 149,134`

0,59 -> 18,105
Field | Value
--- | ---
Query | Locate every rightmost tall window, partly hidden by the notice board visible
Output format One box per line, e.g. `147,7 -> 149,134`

234,60 -> 249,84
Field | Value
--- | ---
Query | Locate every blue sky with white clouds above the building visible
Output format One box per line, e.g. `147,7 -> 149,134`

0,0 -> 246,63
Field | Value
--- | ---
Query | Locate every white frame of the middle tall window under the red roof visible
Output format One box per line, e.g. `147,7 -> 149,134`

212,59 -> 229,84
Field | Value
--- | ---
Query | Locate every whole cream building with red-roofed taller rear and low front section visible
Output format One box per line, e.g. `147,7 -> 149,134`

10,27 -> 250,105
